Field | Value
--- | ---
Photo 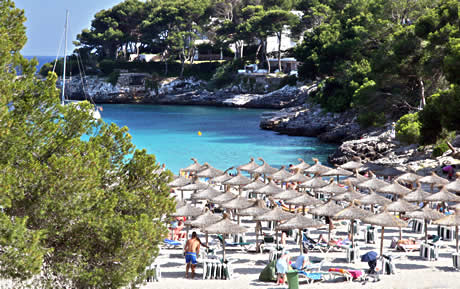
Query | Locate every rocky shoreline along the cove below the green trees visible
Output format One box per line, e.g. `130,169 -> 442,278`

67,73 -> 460,173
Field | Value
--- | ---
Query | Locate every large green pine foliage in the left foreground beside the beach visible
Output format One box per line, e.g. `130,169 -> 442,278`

0,0 -> 175,288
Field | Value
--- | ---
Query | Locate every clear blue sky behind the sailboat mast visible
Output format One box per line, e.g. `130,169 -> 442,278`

14,0 -> 122,56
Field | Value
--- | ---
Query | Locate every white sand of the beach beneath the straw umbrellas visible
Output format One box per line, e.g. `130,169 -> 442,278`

142,213 -> 460,289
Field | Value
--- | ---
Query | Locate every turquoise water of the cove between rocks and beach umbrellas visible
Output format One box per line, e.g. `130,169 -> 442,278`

102,104 -> 336,174
